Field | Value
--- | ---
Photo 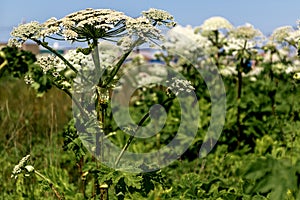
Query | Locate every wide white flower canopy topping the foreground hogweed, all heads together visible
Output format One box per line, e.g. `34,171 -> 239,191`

10,8 -> 175,46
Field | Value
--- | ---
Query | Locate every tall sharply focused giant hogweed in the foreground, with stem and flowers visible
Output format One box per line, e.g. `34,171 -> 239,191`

9,9 -> 184,199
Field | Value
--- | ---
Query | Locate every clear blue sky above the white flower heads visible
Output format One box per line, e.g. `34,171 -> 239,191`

0,0 -> 300,42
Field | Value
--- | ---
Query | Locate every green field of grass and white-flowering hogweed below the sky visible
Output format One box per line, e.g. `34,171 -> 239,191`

0,10 -> 300,200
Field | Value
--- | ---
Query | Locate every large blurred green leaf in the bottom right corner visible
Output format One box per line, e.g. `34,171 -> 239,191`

245,156 -> 300,200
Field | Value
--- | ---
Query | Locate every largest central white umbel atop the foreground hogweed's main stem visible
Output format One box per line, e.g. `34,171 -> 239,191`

42,8 -> 129,41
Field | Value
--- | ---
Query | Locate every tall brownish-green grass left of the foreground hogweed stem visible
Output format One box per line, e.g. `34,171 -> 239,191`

0,77 -> 74,199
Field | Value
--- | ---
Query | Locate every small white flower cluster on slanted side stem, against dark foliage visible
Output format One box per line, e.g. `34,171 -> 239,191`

166,77 -> 195,96
